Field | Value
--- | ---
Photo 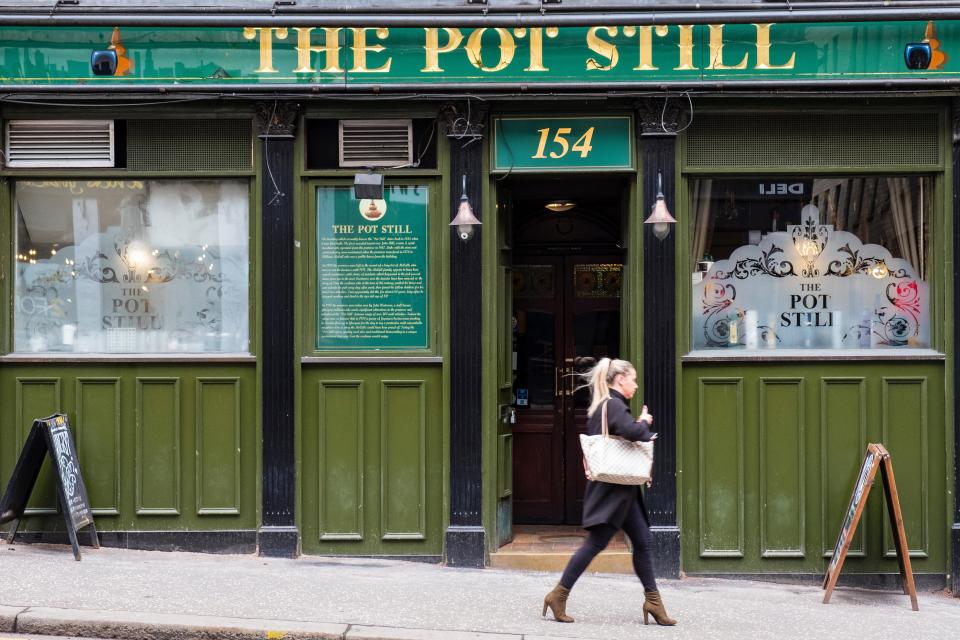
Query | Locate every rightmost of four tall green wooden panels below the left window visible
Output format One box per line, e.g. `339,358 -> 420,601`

196,378 -> 240,515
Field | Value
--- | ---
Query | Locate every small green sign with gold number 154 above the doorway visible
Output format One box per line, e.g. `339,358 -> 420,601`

493,116 -> 633,173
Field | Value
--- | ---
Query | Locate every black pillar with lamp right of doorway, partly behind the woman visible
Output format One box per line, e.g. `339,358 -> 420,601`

636,98 -> 680,578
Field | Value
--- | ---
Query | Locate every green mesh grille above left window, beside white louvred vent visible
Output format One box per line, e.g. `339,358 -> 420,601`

127,119 -> 253,171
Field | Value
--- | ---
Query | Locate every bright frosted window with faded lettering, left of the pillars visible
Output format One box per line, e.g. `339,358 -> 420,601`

14,180 -> 250,353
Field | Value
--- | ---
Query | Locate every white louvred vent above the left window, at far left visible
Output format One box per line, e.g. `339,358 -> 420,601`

6,120 -> 113,167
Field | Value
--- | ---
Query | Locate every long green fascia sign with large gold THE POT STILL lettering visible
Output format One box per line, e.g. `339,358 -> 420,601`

0,18 -> 960,87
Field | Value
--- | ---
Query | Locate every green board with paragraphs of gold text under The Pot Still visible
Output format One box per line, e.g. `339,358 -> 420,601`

316,185 -> 430,351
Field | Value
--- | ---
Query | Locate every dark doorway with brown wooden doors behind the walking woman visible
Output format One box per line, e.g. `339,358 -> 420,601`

502,177 -> 629,525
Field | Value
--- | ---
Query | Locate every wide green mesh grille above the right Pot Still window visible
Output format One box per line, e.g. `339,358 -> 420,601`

684,113 -> 943,169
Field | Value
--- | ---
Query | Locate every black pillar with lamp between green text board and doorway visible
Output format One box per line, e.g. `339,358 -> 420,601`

444,100 -> 486,567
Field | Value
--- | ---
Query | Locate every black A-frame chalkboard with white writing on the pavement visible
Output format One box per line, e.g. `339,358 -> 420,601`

0,414 -> 100,560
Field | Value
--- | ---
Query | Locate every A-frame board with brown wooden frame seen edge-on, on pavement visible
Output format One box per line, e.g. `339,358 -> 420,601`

823,444 -> 920,611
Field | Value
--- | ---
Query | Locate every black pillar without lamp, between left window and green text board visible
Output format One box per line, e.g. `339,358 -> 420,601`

255,101 -> 300,557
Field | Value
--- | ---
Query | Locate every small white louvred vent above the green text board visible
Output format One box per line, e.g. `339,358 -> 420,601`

340,120 -> 413,167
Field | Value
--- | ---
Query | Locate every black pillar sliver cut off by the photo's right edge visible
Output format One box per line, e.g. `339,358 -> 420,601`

950,100 -> 960,598
